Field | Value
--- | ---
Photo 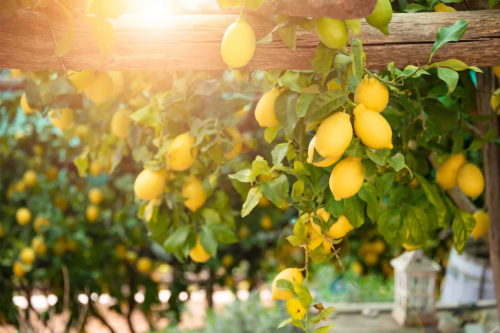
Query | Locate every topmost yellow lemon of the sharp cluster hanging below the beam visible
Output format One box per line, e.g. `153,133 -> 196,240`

354,75 -> 389,113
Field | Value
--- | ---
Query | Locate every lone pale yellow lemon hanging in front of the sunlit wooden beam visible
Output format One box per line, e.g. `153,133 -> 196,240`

221,17 -> 257,68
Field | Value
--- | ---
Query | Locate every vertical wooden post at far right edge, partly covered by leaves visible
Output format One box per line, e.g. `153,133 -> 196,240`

476,68 -> 500,316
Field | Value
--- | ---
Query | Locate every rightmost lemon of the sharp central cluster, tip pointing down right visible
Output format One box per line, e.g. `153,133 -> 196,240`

353,104 -> 392,150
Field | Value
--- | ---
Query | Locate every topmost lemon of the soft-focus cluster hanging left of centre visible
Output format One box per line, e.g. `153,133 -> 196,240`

167,132 -> 198,171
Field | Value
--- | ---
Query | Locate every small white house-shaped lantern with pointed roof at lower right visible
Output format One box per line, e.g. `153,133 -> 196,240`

391,250 -> 441,326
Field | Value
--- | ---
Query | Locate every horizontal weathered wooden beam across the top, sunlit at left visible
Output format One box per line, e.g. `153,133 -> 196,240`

0,10 -> 500,71
